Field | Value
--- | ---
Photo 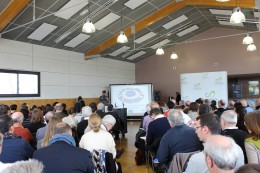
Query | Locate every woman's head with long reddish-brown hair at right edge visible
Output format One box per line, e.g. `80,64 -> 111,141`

245,111 -> 260,141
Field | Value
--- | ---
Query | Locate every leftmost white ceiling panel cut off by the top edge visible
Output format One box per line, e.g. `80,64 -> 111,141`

54,0 -> 88,20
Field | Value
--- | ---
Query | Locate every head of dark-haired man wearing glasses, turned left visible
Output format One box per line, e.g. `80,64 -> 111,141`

195,113 -> 221,142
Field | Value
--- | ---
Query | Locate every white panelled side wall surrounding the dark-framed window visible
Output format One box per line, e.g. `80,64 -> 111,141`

0,38 -> 135,100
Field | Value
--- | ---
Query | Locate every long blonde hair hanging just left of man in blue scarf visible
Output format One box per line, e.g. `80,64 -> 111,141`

37,117 -> 61,149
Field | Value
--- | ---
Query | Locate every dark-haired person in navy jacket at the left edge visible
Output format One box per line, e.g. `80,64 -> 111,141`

0,115 -> 34,163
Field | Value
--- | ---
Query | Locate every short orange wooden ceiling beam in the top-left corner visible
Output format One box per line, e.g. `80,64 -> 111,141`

0,0 -> 30,31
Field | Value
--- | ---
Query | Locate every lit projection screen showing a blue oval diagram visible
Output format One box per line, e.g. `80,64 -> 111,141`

110,84 -> 152,116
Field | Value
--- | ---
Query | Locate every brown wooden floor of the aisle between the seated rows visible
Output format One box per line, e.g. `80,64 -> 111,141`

116,121 -> 153,173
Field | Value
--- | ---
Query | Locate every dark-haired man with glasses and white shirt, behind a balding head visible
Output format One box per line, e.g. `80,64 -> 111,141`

185,113 -> 244,173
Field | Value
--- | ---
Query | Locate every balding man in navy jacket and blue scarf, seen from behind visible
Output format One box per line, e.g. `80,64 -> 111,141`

33,122 -> 94,173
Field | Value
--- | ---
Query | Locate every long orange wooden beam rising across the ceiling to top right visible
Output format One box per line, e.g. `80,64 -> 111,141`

85,0 -> 255,56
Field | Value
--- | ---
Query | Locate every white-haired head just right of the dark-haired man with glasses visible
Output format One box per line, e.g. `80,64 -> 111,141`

220,110 -> 237,129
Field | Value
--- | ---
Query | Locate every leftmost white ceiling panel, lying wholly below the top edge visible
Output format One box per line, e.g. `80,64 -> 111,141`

27,23 -> 57,41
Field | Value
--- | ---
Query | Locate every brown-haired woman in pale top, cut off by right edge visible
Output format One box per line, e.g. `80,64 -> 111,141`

245,111 -> 260,164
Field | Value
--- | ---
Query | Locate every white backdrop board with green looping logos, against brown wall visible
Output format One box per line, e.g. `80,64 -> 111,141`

180,71 -> 228,101
